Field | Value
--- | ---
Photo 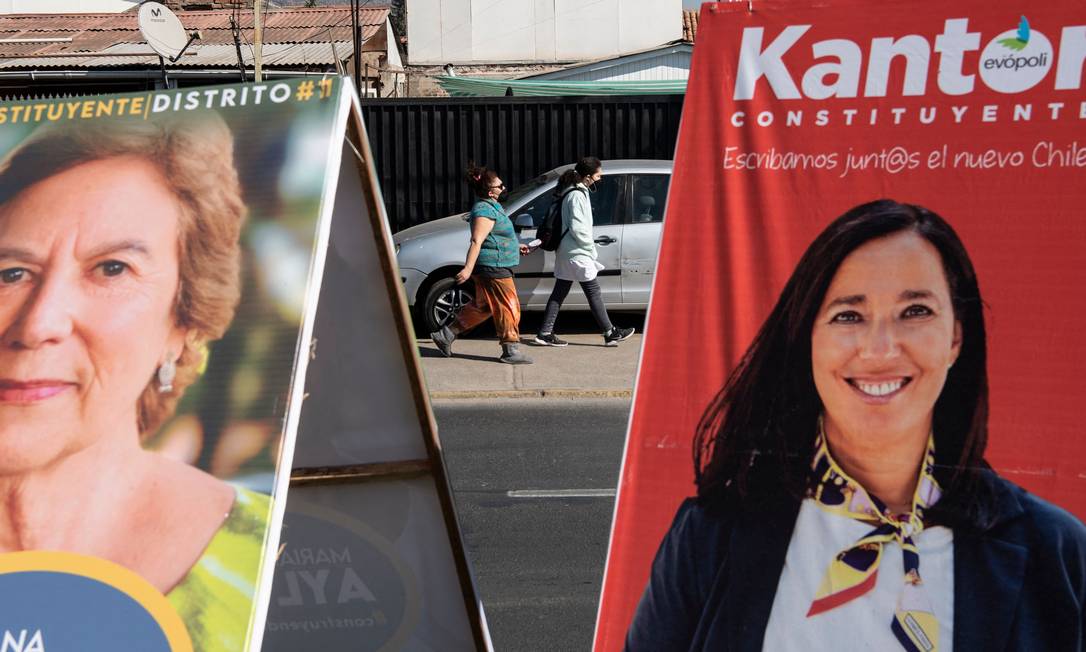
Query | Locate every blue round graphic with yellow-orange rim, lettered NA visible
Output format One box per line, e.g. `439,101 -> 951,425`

0,552 -> 192,652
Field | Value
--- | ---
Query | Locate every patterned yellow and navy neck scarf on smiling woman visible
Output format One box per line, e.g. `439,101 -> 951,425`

807,424 -> 940,652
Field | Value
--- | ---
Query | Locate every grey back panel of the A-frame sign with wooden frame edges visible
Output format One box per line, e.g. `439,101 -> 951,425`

262,88 -> 491,652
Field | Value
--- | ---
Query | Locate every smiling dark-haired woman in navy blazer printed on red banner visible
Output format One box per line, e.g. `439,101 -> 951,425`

627,200 -> 1086,652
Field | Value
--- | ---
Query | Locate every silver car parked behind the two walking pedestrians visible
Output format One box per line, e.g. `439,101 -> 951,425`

392,160 -> 671,331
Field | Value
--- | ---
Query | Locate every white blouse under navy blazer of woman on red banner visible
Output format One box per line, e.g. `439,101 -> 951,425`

762,499 -> 954,652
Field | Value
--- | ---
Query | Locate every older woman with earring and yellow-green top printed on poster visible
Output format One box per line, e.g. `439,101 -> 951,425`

0,116 -> 268,650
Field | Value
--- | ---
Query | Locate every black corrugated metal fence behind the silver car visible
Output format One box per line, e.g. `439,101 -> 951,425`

363,96 -> 683,230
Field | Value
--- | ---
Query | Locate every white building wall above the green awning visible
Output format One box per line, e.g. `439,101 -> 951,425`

407,0 -> 682,64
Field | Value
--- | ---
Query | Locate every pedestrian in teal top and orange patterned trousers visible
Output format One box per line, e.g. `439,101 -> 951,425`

430,163 -> 532,364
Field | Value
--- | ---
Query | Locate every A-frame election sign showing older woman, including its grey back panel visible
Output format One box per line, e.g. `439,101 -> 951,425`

0,76 -> 485,652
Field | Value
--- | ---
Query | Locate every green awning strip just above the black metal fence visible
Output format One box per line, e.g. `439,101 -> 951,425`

437,76 -> 686,98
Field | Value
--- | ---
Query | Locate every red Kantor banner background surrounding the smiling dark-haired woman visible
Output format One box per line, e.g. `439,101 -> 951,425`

595,0 -> 1086,651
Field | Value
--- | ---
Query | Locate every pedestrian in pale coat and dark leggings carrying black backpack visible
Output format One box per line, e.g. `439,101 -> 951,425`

534,156 -> 633,347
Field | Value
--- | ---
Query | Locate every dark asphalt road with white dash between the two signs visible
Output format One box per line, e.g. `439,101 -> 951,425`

434,399 -> 630,652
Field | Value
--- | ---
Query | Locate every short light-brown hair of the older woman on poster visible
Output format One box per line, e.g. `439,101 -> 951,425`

0,112 -> 245,437
